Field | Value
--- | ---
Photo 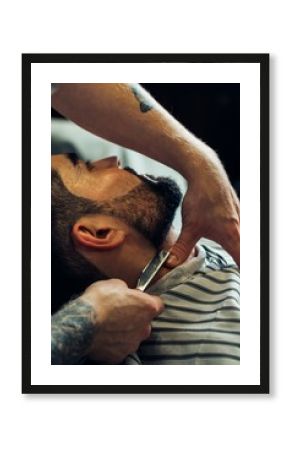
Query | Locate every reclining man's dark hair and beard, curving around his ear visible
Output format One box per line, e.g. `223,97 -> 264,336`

51,170 -> 181,312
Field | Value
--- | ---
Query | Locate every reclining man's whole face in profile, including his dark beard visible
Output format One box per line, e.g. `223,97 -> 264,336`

52,154 -> 182,251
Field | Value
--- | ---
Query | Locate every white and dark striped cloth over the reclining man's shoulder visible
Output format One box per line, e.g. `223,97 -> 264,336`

124,239 -> 240,365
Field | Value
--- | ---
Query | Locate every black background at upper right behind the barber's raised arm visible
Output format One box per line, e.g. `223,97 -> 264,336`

52,83 -> 240,194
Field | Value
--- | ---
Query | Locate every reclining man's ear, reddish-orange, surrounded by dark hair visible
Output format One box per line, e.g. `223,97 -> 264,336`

72,216 -> 126,251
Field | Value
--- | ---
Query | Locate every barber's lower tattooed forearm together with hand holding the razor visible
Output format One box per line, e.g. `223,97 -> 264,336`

51,280 -> 163,364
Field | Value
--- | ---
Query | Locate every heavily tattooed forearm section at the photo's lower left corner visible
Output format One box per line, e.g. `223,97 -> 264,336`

51,297 -> 96,364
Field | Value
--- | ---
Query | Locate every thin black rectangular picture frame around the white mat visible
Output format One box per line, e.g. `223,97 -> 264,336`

22,53 -> 270,394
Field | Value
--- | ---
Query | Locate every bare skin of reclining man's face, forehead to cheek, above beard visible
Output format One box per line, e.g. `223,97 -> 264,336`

51,153 -> 141,201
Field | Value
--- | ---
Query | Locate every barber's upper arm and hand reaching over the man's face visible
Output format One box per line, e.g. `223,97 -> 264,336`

52,83 -> 240,267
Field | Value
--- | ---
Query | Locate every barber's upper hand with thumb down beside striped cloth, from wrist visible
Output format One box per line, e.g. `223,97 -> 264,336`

166,165 -> 240,268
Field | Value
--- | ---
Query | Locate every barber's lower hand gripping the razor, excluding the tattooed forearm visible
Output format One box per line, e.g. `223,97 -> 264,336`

82,280 -> 163,364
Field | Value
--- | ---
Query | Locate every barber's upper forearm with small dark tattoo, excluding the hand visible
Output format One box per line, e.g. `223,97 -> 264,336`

52,83 -> 219,180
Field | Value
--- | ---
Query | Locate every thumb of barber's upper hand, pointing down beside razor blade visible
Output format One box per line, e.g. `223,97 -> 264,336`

166,227 -> 199,269
